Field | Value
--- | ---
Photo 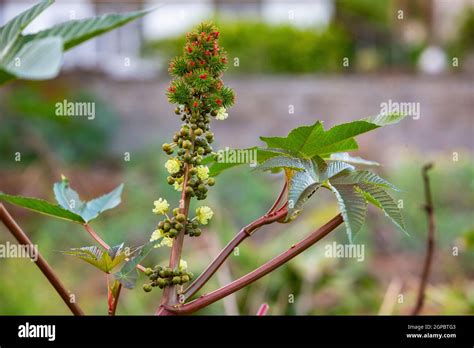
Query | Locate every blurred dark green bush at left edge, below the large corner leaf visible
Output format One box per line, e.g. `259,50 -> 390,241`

0,82 -> 118,167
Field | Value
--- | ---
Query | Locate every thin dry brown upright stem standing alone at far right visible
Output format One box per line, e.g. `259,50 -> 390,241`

412,163 -> 436,315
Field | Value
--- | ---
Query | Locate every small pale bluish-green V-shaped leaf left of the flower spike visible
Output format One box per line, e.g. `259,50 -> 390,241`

53,177 -> 123,222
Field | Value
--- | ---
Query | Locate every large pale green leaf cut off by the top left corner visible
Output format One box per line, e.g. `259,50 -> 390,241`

0,0 -> 150,84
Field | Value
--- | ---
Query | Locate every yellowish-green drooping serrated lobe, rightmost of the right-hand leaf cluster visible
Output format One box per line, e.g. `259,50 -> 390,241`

357,183 -> 408,234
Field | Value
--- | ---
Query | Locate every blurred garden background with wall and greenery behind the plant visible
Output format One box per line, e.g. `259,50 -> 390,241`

0,0 -> 474,315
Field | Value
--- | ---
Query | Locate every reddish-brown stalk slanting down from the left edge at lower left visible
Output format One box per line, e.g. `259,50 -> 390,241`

0,203 -> 84,315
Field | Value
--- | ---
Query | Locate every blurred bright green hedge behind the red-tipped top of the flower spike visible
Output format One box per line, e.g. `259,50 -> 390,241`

145,21 -> 353,73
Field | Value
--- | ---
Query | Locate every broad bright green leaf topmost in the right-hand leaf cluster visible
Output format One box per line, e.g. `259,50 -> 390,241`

260,114 -> 405,159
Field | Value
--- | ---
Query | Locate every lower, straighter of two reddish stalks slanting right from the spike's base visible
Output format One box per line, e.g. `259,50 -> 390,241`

165,214 -> 343,315
